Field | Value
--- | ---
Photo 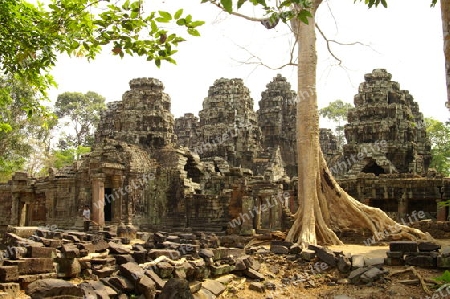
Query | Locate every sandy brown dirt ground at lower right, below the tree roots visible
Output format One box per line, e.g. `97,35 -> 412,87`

219,240 -> 450,299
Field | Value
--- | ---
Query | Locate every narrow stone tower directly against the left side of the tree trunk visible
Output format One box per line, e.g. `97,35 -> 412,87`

258,74 -> 297,176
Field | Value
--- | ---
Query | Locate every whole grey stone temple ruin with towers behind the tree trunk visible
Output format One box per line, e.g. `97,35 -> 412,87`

0,70 -> 450,236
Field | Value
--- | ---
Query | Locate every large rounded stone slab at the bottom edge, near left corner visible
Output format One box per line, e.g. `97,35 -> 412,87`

25,278 -> 83,299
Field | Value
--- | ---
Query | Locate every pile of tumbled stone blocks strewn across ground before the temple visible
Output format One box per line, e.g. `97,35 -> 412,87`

0,229 -> 450,299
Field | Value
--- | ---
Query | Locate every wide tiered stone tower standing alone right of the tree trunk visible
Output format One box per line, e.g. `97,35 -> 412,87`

344,69 -> 431,175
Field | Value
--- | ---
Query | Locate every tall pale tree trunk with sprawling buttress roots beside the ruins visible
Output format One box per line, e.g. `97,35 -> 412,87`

287,0 -> 432,247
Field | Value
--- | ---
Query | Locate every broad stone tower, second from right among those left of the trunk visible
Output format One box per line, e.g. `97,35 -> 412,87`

192,78 -> 261,168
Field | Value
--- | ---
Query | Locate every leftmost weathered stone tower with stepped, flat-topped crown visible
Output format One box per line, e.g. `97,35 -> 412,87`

96,78 -> 176,149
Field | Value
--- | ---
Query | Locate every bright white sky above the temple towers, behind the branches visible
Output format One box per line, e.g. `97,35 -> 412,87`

47,0 -> 449,126
